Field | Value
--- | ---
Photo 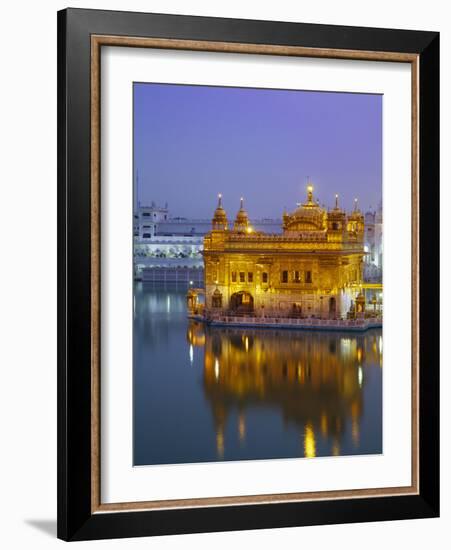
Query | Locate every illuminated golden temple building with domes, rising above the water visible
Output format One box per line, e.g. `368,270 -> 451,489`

204,185 -> 365,319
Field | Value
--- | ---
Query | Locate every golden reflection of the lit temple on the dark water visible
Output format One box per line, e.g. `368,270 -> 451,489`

187,321 -> 382,459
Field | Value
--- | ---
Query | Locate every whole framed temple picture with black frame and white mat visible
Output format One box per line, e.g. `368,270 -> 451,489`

58,9 -> 440,540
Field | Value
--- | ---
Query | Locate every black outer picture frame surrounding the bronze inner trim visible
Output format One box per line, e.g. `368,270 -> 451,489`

58,9 -> 439,540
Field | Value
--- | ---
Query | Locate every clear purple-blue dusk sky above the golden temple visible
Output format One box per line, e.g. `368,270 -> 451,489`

134,83 -> 382,218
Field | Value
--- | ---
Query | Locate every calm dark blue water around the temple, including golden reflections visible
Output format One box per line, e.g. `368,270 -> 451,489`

134,283 -> 382,465
